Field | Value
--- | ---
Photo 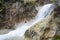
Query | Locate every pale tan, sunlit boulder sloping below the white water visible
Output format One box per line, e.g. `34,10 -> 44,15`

25,12 -> 57,40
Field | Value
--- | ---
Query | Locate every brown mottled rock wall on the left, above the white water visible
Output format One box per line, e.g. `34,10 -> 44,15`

0,0 -> 37,29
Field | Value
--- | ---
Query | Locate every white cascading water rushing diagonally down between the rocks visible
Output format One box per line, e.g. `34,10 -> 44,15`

0,4 -> 55,40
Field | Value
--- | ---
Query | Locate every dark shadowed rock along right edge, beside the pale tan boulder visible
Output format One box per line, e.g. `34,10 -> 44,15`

54,6 -> 60,36
